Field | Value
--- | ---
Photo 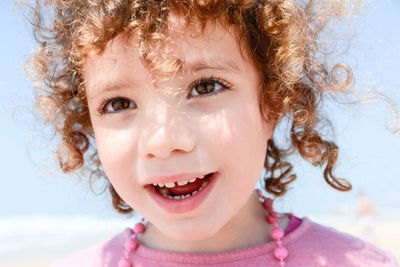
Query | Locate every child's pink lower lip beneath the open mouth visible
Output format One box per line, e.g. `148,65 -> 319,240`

145,173 -> 218,216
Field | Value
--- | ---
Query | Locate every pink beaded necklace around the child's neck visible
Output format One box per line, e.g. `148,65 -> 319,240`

118,189 -> 288,267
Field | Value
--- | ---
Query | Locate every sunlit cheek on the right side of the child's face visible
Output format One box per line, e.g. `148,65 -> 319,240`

200,101 -> 270,172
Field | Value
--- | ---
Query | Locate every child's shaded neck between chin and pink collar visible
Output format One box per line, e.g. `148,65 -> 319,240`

139,192 -> 278,253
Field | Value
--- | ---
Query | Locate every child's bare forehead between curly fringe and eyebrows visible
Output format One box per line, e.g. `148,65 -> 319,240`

83,16 -> 252,96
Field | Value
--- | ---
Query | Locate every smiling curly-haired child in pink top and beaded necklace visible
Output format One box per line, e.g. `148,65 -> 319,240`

26,0 -> 396,267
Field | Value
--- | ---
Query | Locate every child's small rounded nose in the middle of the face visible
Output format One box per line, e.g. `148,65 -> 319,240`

139,100 -> 195,159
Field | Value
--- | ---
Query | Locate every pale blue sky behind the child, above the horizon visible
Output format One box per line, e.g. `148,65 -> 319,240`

0,0 -> 400,219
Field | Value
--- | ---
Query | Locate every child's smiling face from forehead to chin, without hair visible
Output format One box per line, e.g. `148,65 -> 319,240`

84,21 -> 273,243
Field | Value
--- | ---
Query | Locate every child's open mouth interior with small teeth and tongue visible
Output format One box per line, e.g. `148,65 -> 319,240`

153,173 -> 213,200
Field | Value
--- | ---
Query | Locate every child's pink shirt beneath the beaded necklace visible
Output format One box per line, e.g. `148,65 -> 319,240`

52,217 -> 399,267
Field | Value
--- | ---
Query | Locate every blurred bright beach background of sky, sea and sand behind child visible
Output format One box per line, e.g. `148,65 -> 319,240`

0,0 -> 400,267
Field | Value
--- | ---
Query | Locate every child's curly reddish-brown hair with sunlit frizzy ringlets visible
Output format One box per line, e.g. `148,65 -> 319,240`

28,0 -> 353,213
